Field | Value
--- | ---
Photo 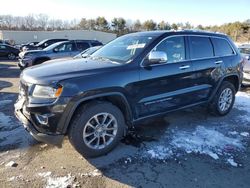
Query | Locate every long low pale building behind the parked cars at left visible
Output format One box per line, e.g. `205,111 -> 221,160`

0,30 -> 116,44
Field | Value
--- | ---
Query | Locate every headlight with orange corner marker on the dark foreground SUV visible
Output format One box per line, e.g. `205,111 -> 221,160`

32,85 -> 62,98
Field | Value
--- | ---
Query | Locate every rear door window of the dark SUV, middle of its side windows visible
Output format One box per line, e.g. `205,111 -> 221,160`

189,37 -> 214,59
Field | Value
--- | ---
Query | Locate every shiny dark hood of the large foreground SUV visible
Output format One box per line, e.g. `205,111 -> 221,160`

21,58 -> 122,85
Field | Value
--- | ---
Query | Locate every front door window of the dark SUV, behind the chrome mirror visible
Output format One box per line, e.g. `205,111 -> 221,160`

154,37 -> 185,63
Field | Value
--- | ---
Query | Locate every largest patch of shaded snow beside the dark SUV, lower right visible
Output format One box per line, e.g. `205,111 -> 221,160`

146,126 -> 244,160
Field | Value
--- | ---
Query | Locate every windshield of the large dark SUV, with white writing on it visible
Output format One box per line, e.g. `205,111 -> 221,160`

91,35 -> 153,63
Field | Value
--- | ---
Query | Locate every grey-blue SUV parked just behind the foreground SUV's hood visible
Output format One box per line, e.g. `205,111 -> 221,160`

18,40 -> 101,69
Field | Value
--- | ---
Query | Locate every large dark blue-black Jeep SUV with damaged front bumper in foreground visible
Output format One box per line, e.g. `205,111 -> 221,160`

15,31 -> 243,157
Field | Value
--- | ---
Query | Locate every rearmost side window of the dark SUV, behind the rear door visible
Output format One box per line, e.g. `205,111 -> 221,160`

211,38 -> 234,56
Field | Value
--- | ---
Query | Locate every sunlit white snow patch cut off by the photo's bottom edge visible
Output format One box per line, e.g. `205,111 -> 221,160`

46,174 -> 75,188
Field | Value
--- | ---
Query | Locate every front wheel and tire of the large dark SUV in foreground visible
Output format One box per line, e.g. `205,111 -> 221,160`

68,102 -> 125,157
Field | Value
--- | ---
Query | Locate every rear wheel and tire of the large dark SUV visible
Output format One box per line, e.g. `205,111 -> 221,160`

209,81 -> 236,116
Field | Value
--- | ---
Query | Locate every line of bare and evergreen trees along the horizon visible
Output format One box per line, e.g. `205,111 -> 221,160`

0,14 -> 250,42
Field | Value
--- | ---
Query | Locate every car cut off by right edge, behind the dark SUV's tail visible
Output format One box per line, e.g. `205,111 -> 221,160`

239,44 -> 250,86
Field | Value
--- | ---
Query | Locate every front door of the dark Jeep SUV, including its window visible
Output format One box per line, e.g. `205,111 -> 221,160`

136,36 -> 196,118
